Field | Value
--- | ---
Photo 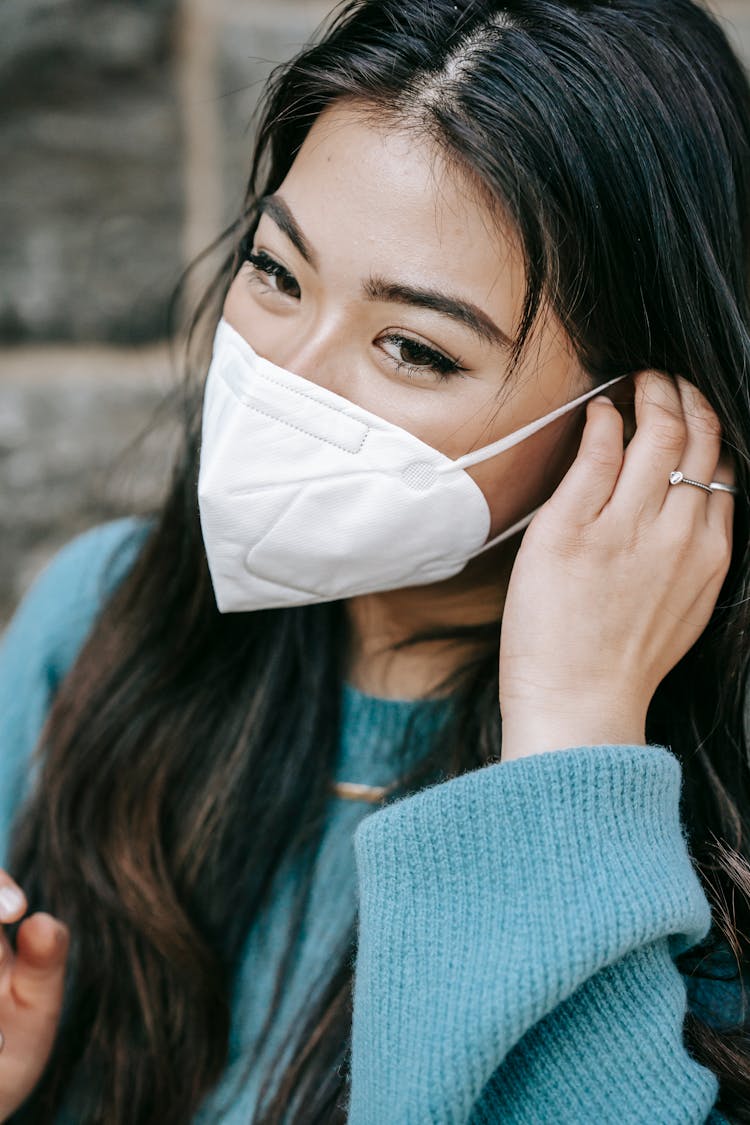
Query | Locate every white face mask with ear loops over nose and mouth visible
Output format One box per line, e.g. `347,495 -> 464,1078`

198,320 -> 625,613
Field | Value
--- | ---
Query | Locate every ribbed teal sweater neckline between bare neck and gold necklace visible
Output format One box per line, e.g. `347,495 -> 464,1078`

336,681 -> 451,785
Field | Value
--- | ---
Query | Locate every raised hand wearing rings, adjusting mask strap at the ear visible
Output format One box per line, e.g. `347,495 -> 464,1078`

499,371 -> 734,761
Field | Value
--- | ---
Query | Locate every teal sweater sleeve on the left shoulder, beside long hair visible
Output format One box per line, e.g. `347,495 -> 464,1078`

0,519 -> 148,867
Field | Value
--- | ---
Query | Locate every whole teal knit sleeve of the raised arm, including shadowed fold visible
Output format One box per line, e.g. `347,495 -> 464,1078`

349,746 -> 724,1125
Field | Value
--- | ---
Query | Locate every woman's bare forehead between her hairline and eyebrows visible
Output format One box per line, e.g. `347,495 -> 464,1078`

273,104 -> 523,302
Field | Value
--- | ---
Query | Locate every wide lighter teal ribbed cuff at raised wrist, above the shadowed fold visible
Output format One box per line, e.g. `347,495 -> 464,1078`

349,746 -> 715,1125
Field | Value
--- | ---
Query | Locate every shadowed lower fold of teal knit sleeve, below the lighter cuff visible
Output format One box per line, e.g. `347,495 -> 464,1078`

471,939 -> 719,1125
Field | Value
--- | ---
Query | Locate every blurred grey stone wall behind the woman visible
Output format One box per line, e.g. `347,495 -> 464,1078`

0,0 -> 750,628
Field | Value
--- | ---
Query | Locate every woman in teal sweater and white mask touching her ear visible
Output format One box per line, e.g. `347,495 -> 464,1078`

0,0 -> 750,1125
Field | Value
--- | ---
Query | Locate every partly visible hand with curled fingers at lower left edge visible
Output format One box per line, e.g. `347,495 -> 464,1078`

0,869 -> 70,1121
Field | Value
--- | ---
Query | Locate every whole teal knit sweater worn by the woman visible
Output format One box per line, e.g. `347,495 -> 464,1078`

0,520 -> 741,1125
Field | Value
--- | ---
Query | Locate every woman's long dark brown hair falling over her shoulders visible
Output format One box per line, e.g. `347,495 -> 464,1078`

5,0 -> 750,1125
